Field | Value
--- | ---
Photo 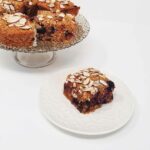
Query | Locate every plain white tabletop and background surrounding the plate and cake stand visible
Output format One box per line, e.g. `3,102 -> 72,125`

0,0 -> 150,150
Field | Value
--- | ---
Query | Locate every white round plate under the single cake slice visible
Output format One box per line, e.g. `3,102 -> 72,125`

40,69 -> 135,135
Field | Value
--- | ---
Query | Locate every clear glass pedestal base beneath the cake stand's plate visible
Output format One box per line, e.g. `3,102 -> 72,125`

15,51 -> 55,68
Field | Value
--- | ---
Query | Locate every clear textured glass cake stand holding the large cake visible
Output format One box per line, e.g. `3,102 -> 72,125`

1,15 -> 90,68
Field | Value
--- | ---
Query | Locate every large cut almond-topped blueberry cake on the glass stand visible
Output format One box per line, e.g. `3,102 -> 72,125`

0,0 -> 80,48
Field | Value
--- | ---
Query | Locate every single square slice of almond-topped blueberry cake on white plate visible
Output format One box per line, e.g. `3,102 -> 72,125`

64,68 -> 115,113
